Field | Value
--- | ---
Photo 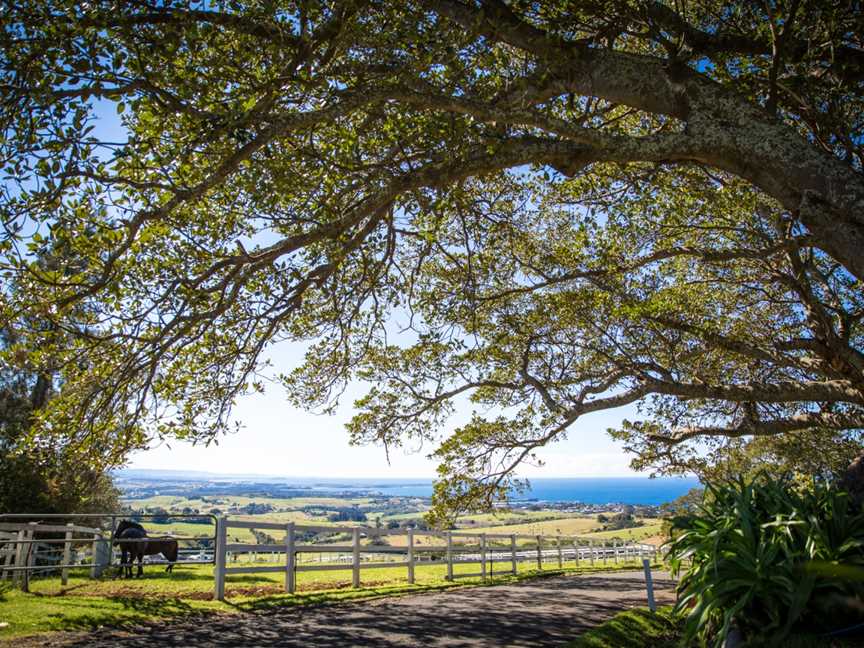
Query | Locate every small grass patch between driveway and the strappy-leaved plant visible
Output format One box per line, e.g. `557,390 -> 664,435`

568,607 -> 682,648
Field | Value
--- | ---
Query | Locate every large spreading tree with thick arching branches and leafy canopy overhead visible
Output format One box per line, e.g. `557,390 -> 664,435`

0,0 -> 864,516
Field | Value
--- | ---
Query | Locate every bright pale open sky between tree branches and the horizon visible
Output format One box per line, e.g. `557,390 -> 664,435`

129,334 -> 636,478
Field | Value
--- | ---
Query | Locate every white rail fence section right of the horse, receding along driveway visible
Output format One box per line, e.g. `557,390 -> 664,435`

214,517 -> 657,601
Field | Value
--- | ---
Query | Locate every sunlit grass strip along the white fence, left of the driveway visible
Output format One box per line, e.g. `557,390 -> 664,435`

0,561 -> 660,640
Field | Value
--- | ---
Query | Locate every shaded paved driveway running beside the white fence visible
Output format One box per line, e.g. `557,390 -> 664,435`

43,572 -> 673,648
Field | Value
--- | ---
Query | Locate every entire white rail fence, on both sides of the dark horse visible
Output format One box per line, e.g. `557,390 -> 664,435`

0,514 -> 657,600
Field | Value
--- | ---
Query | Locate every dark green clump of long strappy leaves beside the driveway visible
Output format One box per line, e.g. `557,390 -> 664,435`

669,476 -> 864,646
